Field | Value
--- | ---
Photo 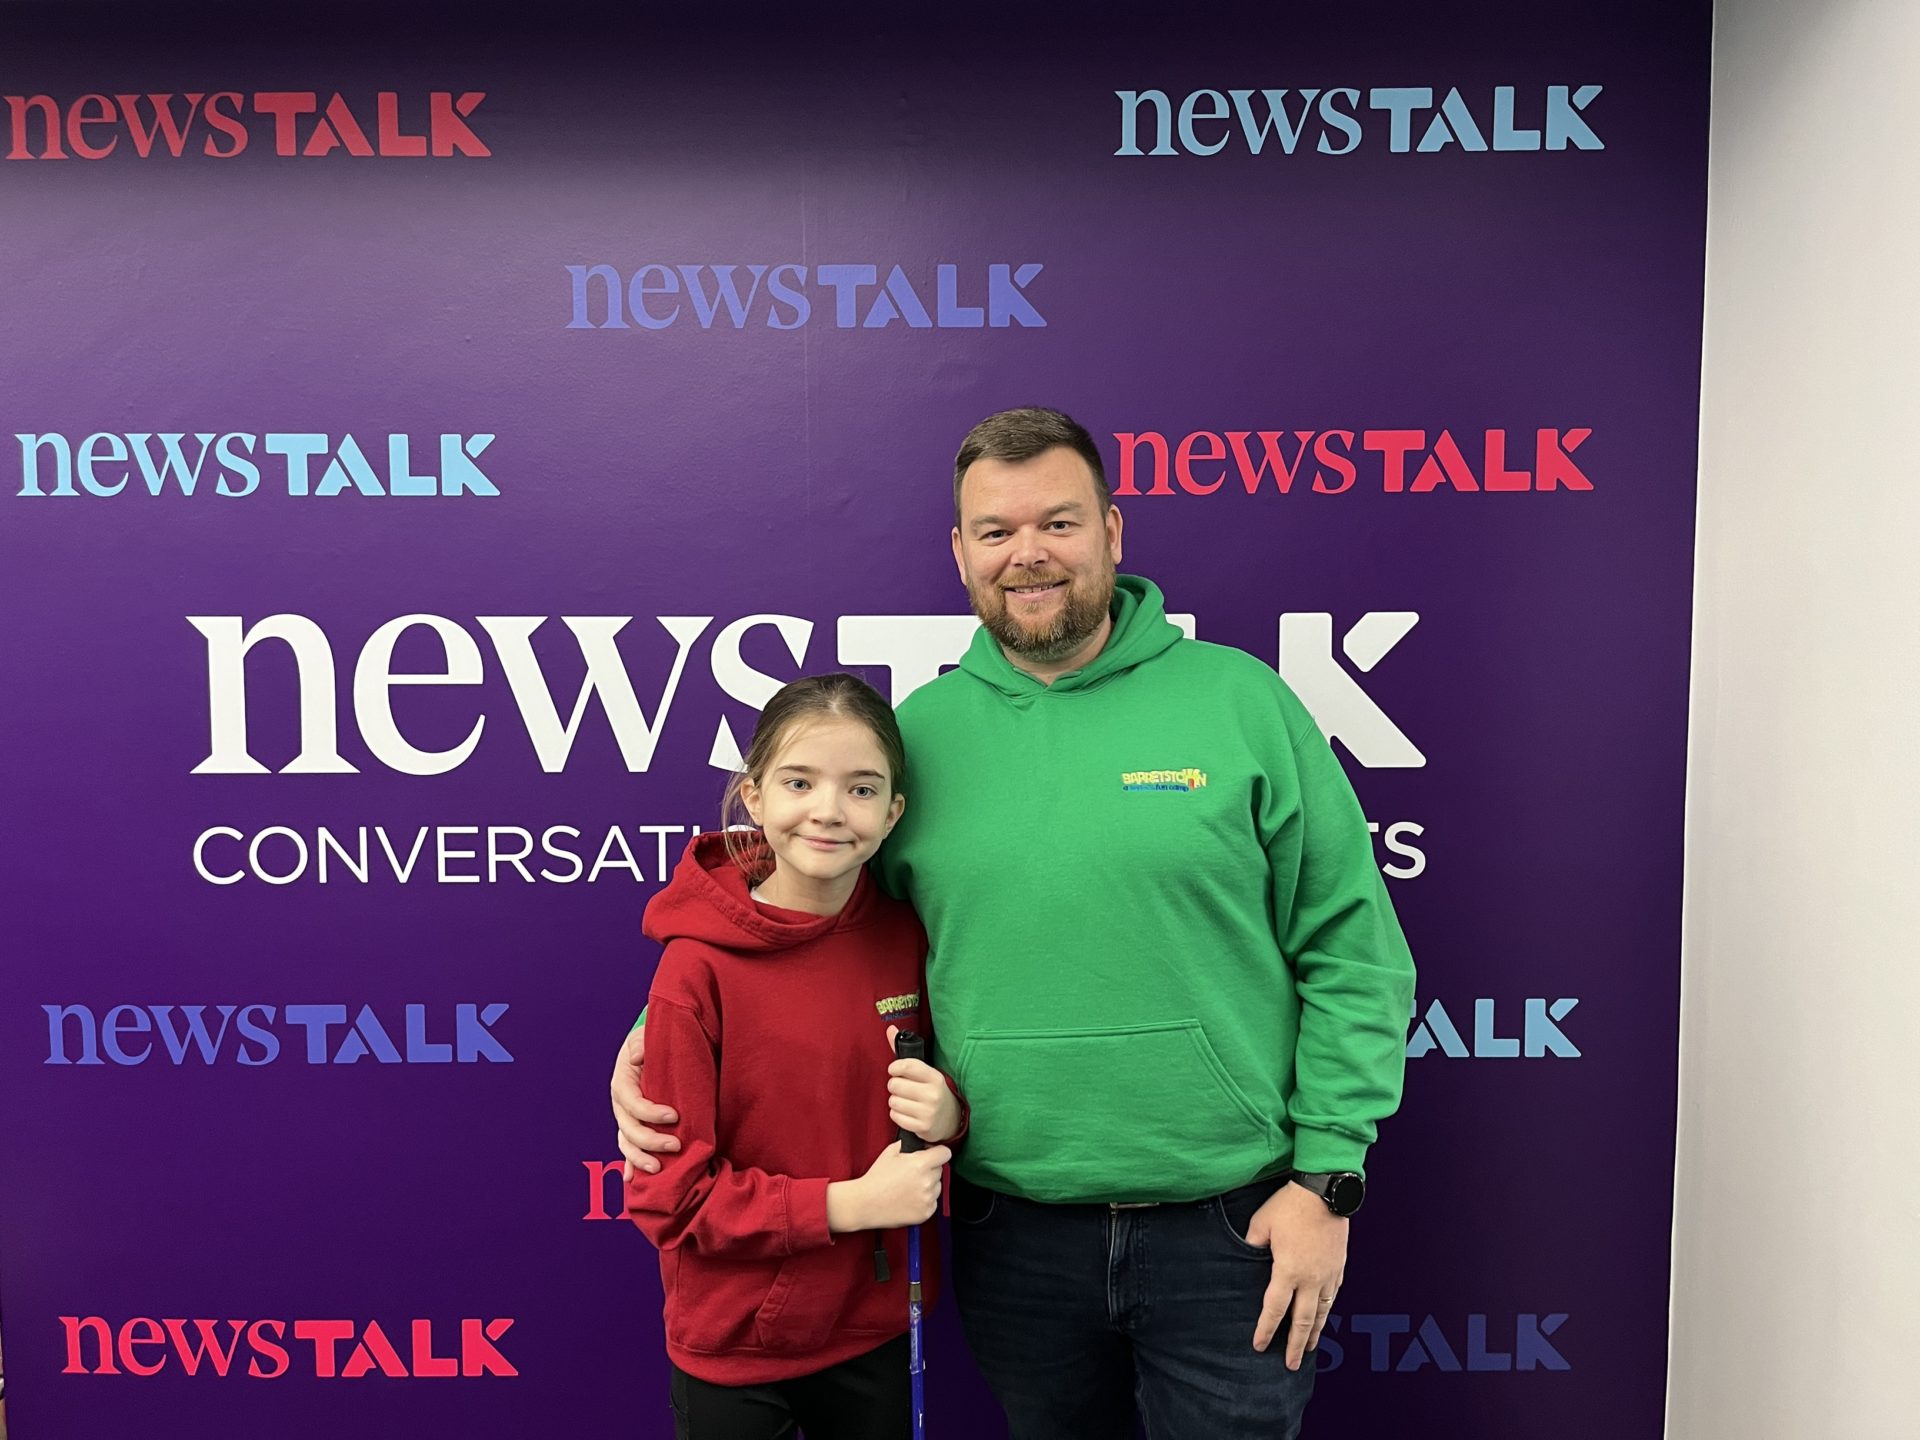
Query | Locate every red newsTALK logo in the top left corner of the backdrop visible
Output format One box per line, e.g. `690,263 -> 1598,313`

0,90 -> 493,159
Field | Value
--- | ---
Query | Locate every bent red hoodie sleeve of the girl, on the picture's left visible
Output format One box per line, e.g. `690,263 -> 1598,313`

626,995 -> 833,1260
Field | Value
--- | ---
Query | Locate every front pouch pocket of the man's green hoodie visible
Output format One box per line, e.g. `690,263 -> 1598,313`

958,1020 -> 1277,1202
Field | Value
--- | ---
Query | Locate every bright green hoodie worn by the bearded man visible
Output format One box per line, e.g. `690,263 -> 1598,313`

874,576 -> 1413,1202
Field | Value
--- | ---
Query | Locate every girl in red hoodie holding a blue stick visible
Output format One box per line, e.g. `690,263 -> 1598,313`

626,674 -> 966,1440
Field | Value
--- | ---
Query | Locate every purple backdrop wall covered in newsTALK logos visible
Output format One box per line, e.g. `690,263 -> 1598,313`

0,2 -> 1709,1440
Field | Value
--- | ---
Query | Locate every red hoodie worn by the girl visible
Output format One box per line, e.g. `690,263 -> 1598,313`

626,835 -> 960,1384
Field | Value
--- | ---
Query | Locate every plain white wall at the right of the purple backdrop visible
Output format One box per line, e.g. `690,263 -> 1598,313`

1666,0 -> 1920,1440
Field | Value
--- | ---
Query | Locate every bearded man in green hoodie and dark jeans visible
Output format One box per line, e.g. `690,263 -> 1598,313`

612,409 -> 1413,1440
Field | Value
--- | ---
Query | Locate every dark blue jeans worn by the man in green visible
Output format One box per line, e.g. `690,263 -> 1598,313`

952,1177 -> 1313,1440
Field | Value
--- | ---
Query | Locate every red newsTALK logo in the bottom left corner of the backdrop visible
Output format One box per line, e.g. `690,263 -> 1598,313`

60,1315 -> 520,1380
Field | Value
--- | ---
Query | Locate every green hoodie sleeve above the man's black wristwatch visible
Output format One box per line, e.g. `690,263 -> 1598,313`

1261,706 -> 1413,1173
